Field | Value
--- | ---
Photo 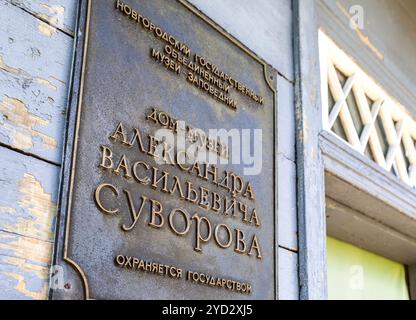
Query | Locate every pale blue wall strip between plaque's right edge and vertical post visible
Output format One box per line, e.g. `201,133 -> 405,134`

191,0 -> 299,292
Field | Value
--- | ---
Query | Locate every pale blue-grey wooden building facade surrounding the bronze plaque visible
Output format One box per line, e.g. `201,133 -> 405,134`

0,0 -> 416,300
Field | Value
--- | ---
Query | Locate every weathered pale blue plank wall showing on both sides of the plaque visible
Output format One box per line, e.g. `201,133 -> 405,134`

0,0 -> 299,299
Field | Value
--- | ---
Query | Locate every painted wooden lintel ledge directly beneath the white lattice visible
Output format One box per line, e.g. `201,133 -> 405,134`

320,131 -> 416,237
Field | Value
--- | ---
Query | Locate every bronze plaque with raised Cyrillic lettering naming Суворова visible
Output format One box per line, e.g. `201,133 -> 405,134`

51,0 -> 277,299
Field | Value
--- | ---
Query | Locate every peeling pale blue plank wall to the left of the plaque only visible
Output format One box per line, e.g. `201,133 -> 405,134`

0,0 -> 76,299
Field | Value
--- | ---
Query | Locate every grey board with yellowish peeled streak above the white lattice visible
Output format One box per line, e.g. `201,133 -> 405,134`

316,0 -> 416,116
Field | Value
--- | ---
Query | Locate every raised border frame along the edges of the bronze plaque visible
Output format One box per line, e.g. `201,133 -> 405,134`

49,0 -> 279,300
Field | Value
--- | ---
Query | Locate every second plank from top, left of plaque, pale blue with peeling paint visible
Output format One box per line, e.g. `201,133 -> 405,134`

0,0 -> 73,163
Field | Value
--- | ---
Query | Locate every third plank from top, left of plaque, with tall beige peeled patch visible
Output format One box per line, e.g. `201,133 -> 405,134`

0,147 -> 59,241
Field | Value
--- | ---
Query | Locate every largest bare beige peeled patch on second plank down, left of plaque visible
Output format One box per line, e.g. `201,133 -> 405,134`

0,96 -> 57,150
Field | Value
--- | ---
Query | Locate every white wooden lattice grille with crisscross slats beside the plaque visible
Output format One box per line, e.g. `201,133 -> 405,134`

319,32 -> 416,188
